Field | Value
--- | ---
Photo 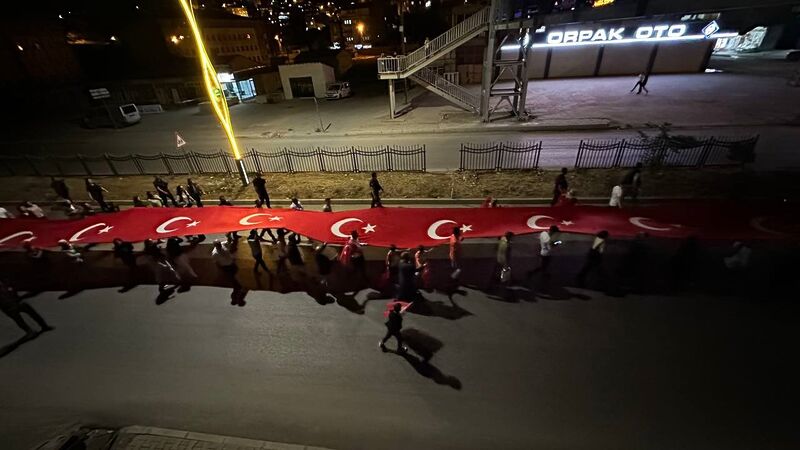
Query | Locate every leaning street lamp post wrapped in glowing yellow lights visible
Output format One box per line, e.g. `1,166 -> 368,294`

178,0 -> 250,186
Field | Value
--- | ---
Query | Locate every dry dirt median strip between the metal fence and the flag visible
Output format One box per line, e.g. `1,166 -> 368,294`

0,168 -> 800,203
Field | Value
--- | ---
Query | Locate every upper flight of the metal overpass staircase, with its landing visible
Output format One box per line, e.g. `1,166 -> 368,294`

378,7 -> 489,80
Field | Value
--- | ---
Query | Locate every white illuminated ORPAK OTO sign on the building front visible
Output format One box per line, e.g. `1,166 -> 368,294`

503,22 -> 738,49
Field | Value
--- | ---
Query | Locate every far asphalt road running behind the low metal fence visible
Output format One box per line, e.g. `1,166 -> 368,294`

0,118 -> 800,171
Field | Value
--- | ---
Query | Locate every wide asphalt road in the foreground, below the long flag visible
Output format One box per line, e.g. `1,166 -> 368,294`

0,280 -> 800,450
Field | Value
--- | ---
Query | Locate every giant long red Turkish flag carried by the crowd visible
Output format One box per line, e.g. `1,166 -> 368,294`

0,202 -> 800,249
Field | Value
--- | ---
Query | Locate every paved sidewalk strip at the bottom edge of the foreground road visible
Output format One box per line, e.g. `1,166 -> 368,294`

111,425 -> 331,450
